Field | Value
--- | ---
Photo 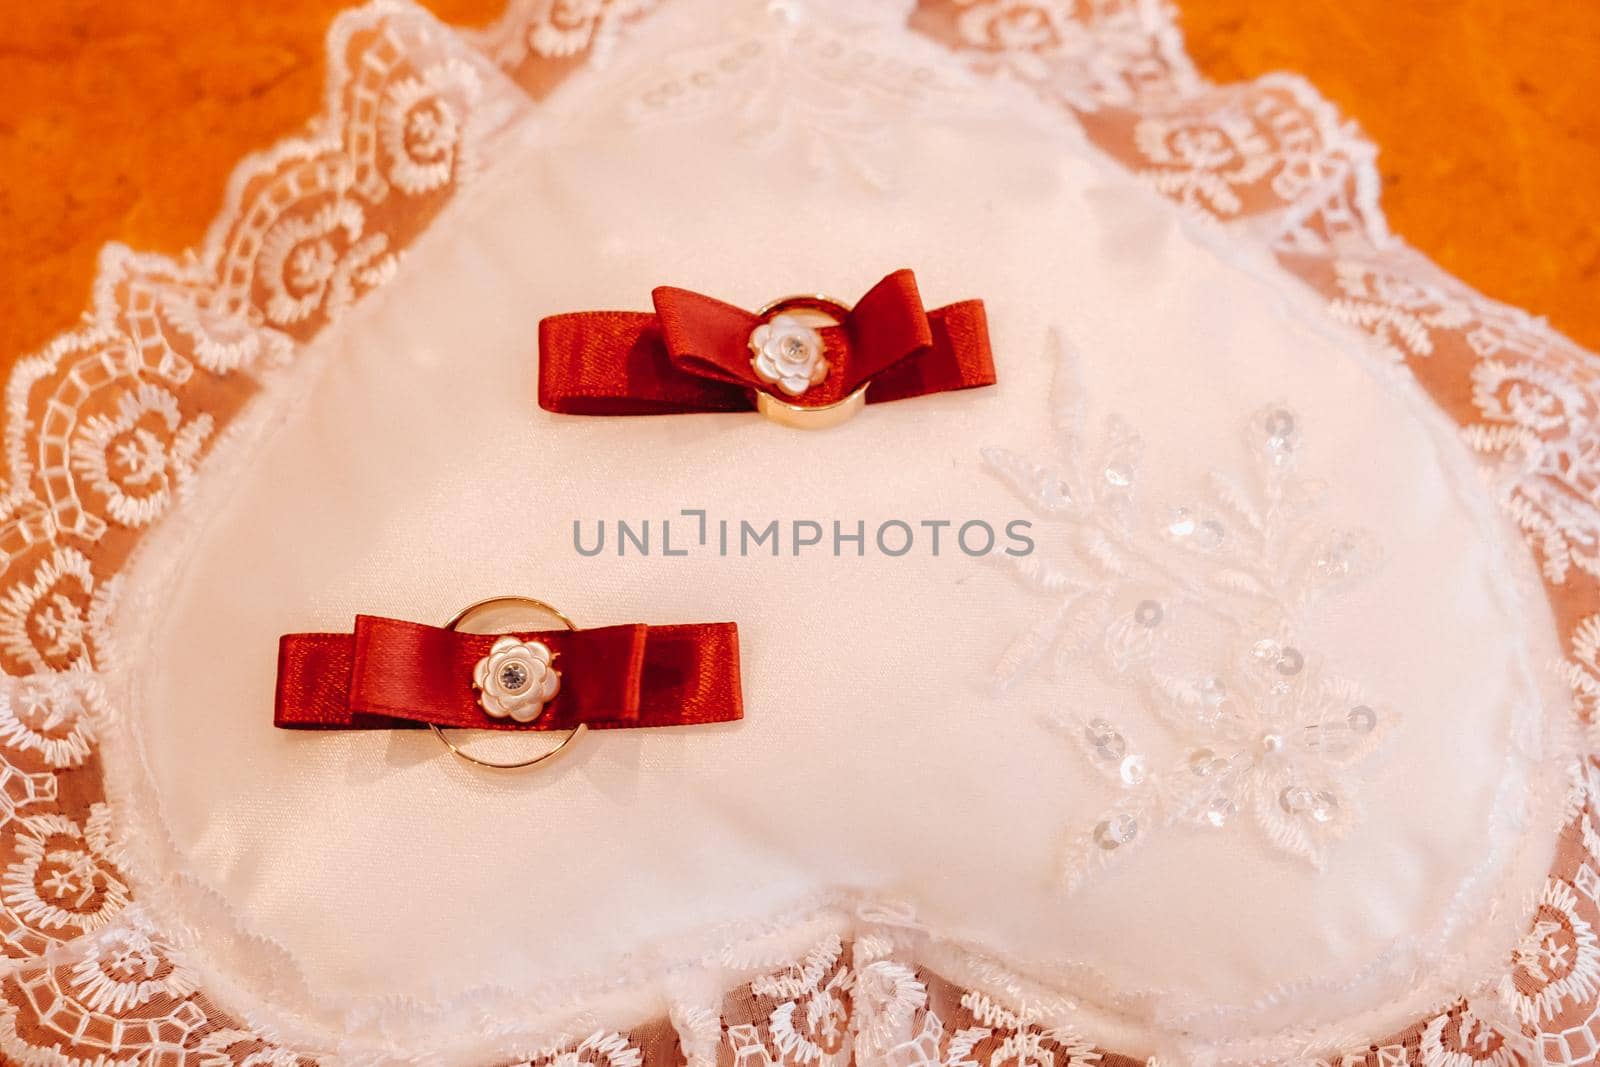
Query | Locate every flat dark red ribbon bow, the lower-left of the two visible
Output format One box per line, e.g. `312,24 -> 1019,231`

272,616 -> 744,729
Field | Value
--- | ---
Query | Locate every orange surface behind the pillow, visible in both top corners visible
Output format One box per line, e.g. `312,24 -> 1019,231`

0,0 -> 1600,365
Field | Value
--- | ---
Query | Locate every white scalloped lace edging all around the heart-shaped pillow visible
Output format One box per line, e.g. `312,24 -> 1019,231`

0,0 -> 1600,1067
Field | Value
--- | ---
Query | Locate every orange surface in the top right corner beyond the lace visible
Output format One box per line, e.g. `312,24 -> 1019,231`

1179,0 -> 1600,350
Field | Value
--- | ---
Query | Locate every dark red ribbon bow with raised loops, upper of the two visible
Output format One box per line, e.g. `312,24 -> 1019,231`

539,270 -> 995,414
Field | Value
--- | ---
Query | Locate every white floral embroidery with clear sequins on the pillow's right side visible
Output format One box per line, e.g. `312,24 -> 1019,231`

984,342 -> 1394,889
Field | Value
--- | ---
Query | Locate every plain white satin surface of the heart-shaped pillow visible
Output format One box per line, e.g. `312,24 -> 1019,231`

124,12 -> 1566,1064
